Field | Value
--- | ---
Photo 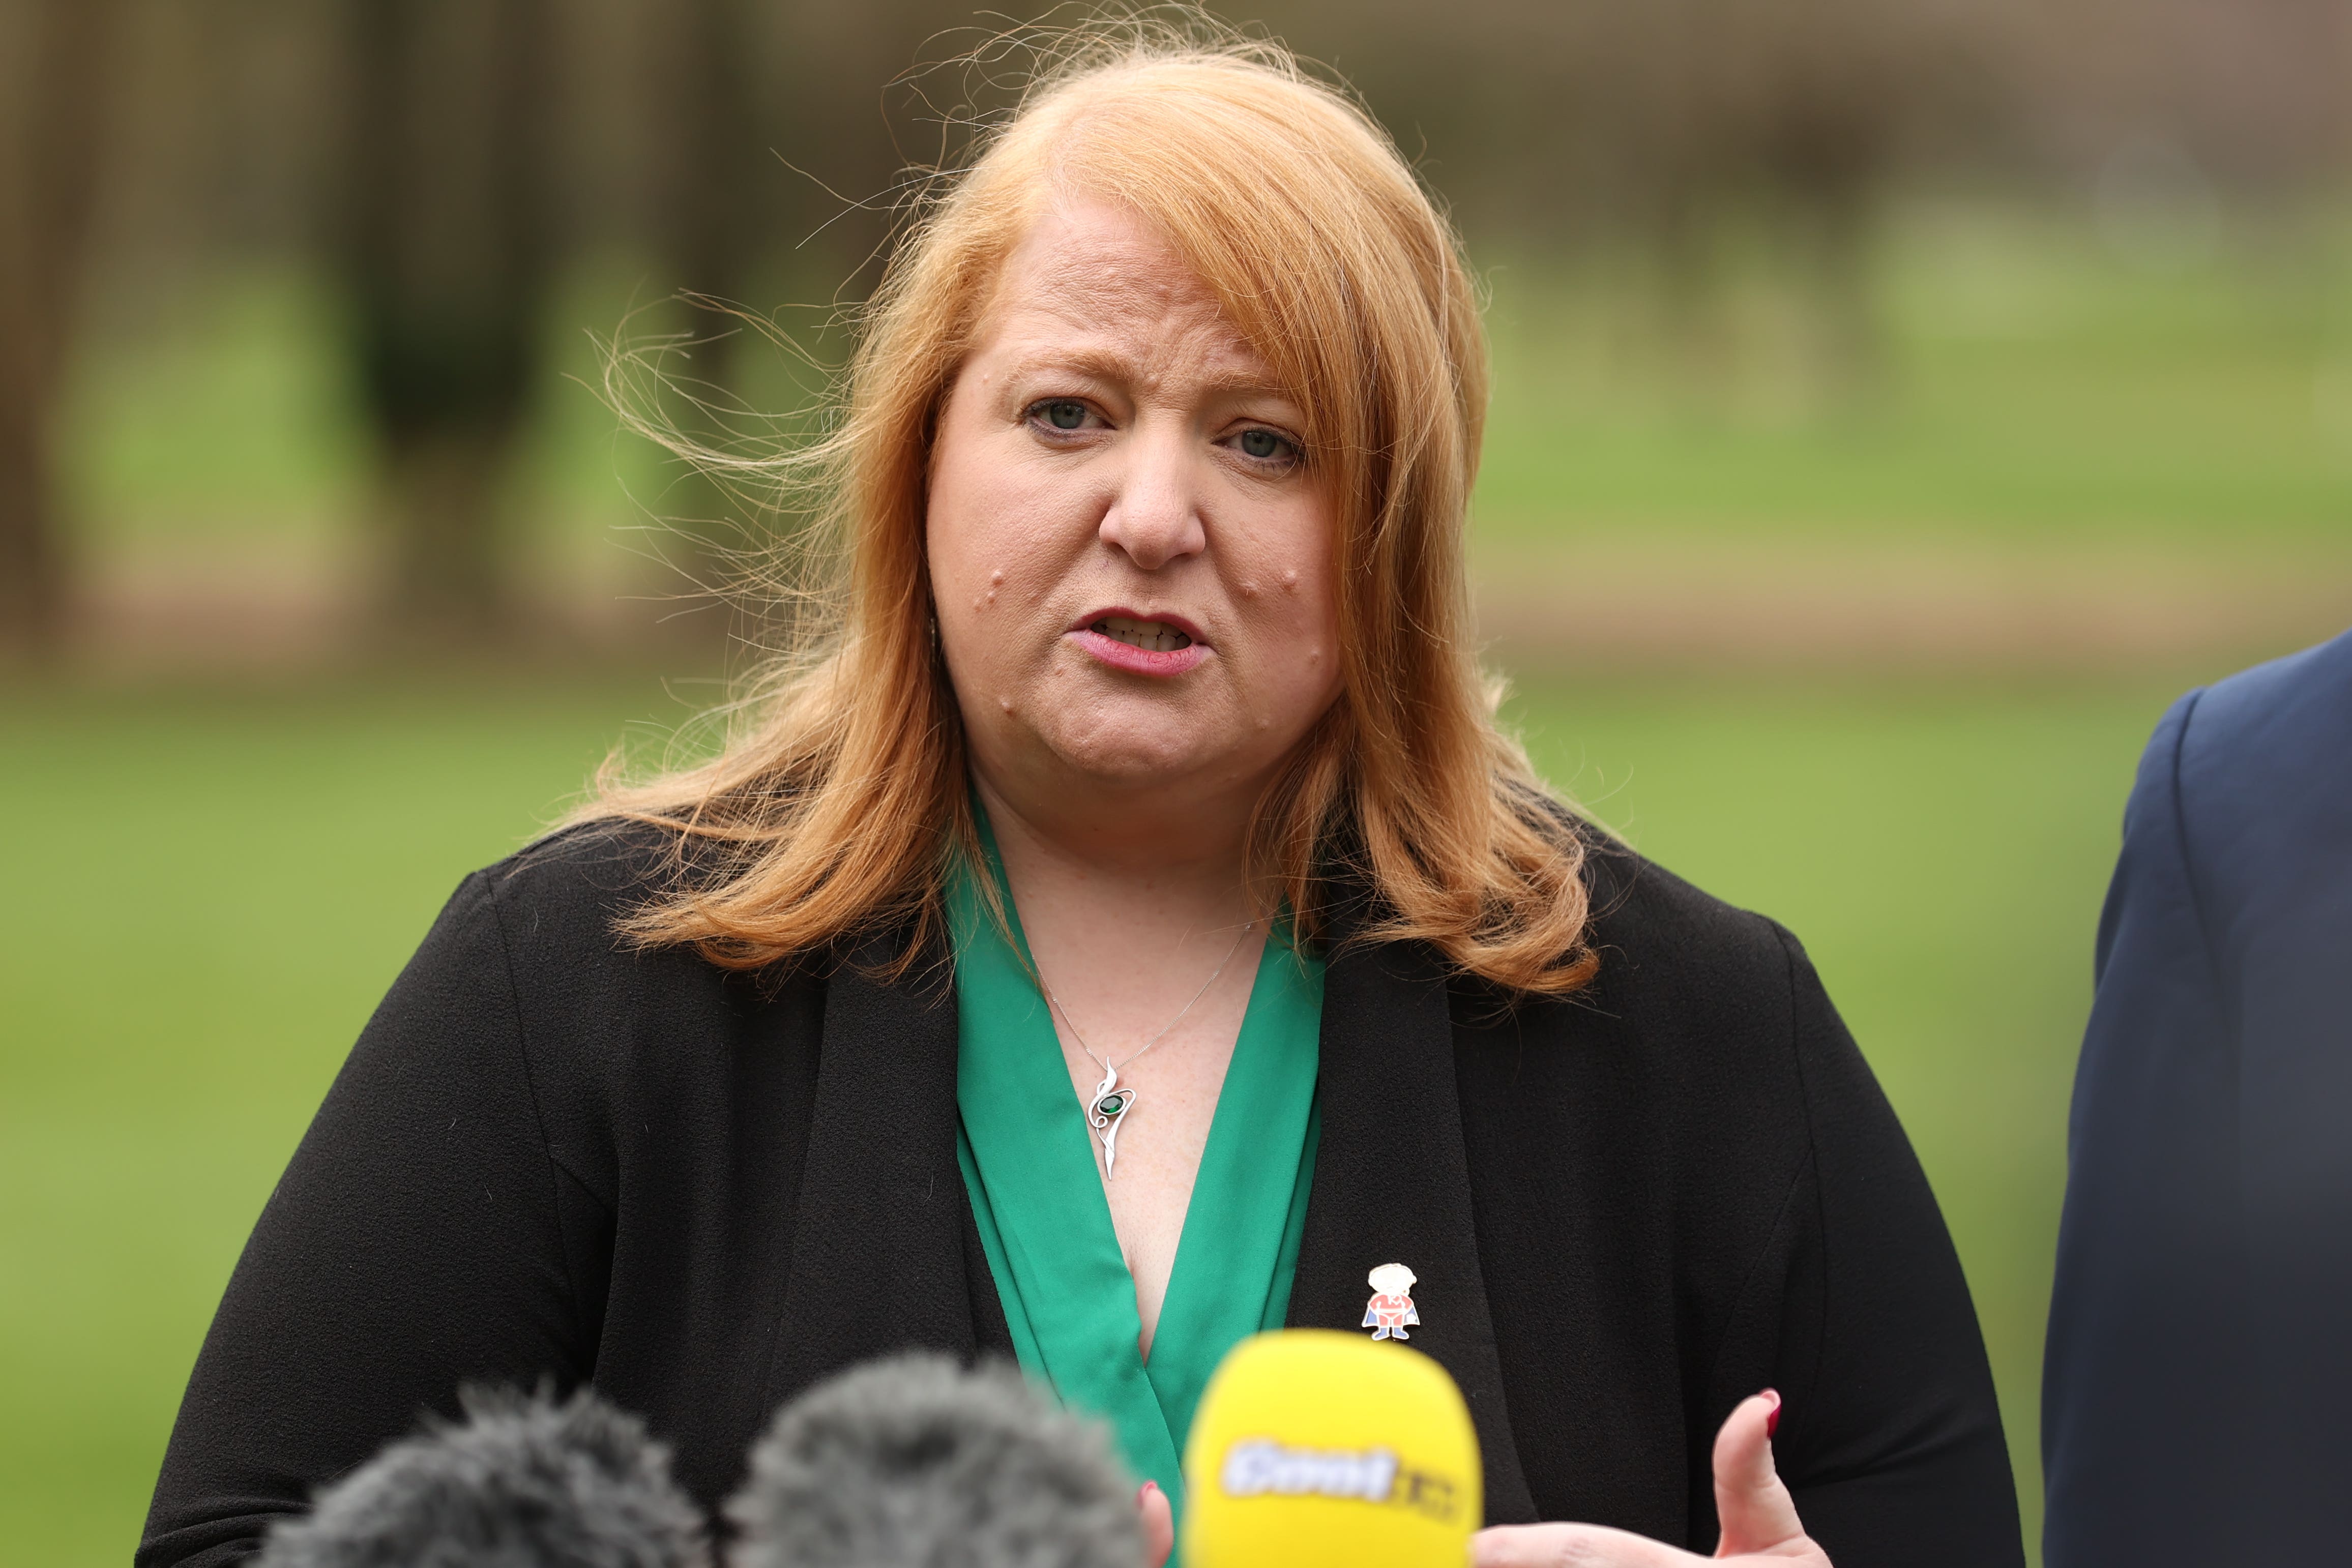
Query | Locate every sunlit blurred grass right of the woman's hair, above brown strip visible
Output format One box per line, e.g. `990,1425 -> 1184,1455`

1479,207 -> 2352,557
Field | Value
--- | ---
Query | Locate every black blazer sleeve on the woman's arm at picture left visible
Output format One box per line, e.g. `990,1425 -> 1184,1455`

136,874 -> 593,1568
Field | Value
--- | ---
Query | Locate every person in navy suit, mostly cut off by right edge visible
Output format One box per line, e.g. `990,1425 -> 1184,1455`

2042,632 -> 2352,1568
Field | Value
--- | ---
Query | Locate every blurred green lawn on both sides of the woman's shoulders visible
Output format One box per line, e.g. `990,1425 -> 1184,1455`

0,679 -> 2171,1568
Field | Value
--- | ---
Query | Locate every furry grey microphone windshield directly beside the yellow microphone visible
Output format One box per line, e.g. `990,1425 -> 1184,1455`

727,1354 -> 1143,1568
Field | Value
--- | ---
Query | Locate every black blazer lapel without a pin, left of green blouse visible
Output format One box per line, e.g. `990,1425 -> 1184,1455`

765,942 -> 1009,1408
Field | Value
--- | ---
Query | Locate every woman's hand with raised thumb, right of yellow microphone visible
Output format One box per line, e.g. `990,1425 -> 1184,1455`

1470,1389 -> 1830,1568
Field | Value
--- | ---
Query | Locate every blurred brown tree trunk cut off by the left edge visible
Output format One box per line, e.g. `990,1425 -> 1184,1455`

0,0 -> 120,654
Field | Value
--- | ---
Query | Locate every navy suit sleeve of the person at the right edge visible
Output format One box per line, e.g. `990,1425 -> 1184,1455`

2042,694 -> 2246,1568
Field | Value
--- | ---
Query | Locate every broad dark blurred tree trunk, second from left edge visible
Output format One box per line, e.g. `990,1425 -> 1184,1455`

343,0 -> 550,637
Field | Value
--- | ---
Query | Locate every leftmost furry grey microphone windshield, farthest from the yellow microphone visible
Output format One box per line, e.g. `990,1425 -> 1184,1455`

256,1389 -> 710,1568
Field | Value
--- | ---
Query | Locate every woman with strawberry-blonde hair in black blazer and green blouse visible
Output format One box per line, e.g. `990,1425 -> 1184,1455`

141,27 -> 2020,1568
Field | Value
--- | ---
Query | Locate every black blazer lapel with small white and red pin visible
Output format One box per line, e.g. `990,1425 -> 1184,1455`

1289,942 -> 1536,1523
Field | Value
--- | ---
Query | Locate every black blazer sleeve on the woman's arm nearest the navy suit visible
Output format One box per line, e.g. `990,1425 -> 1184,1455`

1769,931 -> 2025,1568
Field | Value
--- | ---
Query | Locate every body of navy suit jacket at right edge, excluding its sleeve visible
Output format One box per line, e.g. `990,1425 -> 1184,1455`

2180,635 -> 2352,1563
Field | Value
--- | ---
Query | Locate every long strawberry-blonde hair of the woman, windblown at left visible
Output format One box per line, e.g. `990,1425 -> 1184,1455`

581,28 -> 1595,994
